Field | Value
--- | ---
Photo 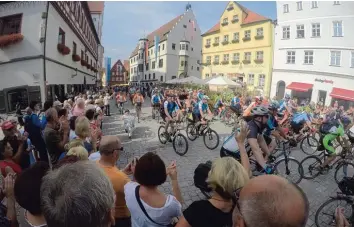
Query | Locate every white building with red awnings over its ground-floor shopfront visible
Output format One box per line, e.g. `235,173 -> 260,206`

271,1 -> 354,107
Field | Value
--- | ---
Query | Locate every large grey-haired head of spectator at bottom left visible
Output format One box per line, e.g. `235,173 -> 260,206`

41,161 -> 118,227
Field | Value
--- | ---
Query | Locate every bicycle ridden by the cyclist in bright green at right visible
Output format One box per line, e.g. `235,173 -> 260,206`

301,135 -> 354,183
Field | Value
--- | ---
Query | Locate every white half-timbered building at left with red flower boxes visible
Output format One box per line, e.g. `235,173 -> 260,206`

0,2 -> 100,111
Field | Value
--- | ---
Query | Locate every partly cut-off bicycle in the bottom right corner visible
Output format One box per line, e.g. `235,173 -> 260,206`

315,181 -> 354,227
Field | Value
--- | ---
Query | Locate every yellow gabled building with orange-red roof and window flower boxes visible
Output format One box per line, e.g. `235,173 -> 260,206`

202,1 -> 274,96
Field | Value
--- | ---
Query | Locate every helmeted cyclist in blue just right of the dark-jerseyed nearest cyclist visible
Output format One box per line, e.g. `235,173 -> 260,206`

263,101 -> 287,153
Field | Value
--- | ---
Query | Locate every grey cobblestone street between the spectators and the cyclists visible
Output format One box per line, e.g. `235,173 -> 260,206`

103,99 -> 339,226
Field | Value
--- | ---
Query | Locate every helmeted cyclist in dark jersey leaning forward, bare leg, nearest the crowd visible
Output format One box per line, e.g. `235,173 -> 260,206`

247,106 -> 273,174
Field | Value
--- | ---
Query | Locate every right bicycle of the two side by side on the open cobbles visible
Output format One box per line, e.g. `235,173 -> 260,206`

186,118 -> 220,150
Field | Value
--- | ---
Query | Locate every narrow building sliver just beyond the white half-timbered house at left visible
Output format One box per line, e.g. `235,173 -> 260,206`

88,1 -> 104,86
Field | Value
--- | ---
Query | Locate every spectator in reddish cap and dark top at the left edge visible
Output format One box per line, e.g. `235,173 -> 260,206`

1,121 -> 30,169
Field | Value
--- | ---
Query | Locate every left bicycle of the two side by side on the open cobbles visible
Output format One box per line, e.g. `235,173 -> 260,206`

158,120 -> 188,156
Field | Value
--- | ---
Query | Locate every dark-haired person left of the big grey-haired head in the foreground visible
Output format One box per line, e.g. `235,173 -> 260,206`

14,162 -> 49,227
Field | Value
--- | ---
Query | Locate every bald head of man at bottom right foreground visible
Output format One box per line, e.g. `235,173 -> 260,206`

233,175 -> 308,227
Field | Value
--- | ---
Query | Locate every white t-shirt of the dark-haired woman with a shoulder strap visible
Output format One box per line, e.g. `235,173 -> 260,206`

124,181 -> 182,227
